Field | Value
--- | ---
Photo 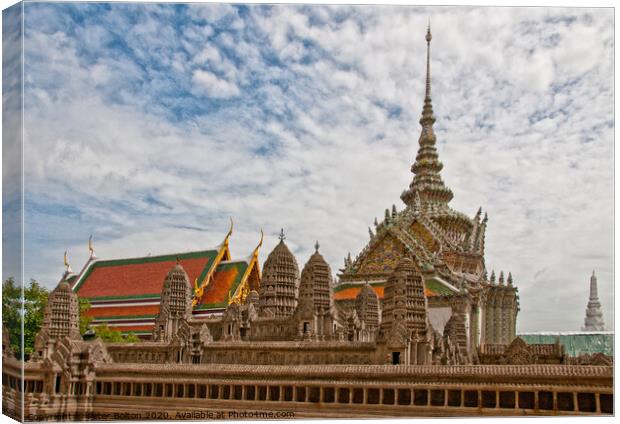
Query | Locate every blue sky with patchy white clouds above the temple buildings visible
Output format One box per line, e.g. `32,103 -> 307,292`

4,3 -> 614,332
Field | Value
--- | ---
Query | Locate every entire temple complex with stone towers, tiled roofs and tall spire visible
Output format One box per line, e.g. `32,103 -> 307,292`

3,28 -> 613,420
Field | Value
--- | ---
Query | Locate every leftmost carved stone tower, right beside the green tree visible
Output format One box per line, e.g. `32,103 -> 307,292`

33,278 -> 82,360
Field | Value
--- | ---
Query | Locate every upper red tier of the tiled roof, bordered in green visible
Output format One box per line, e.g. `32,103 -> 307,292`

73,250 -> 217,300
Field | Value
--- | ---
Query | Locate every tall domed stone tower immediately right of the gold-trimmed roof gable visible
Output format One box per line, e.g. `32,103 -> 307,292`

258,230 -> 299,317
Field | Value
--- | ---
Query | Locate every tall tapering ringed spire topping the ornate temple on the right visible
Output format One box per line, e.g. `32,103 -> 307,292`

400,21 -> 453,207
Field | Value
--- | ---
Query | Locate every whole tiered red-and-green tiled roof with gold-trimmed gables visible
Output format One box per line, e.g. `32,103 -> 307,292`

72,225 -> 260,335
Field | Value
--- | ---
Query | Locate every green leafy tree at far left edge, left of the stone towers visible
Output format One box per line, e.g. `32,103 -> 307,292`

2,277 -> 49,360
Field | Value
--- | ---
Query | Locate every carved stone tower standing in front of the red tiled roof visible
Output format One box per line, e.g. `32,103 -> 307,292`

153,262 -> 193,342
